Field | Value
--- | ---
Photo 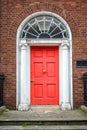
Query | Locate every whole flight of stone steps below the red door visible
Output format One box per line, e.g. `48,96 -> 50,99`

0,108 -> 87,130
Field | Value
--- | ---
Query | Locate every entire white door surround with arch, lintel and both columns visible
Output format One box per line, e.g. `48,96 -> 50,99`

16,11 -> 73,110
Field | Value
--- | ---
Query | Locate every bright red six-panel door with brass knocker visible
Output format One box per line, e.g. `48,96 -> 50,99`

31,46 -> 59,104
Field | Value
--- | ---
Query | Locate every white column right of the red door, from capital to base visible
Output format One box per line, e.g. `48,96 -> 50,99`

61,41 -> 71,110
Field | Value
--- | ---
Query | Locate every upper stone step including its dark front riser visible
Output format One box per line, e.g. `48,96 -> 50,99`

0,108 -> 87,126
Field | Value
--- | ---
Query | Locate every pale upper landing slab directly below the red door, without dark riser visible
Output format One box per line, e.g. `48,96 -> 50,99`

0,106 -> 87,121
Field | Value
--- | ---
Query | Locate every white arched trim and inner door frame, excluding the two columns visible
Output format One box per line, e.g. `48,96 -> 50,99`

16,11 -> 73,108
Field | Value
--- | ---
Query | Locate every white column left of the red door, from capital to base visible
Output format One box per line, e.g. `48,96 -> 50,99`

18,40 -> 29,110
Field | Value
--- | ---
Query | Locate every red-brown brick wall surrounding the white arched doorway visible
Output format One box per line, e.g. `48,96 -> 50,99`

0,0 -> 87,109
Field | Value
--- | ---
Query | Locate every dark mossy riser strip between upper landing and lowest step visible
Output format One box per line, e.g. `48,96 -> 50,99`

0,119 -> 87,126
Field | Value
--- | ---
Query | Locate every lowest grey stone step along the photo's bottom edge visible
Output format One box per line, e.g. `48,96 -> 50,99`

0,125 -> 87,130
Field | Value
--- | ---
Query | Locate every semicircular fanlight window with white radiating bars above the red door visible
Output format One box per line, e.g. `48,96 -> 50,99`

21,16 -> 69,39
